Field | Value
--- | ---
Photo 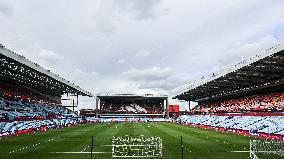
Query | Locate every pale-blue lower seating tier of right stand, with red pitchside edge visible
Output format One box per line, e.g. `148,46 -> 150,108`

177,115 -> 284,140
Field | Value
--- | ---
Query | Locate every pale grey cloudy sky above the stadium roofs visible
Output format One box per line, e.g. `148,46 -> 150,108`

0,0 -> 284,107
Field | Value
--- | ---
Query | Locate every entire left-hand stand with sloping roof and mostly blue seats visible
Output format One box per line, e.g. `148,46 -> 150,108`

0,45 -> 93,136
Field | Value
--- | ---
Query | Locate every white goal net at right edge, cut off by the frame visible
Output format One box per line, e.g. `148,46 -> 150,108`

250,140 -> 284,159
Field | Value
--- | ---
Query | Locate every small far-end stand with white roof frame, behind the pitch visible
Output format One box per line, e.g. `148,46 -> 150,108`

96,94 -> 169,118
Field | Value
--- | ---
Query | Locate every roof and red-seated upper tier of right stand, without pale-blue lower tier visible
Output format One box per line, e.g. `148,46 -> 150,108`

176,45 -> 284,113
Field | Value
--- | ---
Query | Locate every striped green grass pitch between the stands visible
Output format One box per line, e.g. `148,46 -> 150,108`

0,123 -> 277,159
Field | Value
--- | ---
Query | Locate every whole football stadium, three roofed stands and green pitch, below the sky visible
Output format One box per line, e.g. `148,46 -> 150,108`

0,42 -> 284,159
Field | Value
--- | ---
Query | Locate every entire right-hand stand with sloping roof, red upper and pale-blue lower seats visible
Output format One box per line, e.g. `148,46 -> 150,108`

176,45 -> 284,140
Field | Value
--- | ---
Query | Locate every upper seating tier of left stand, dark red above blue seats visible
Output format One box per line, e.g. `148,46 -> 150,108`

0,82 -> 77,120
